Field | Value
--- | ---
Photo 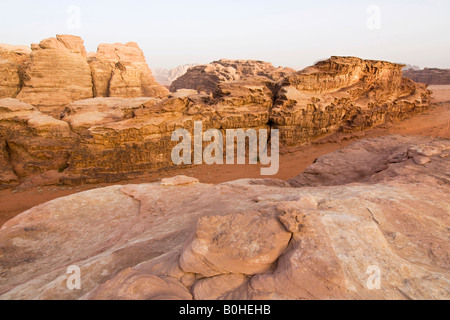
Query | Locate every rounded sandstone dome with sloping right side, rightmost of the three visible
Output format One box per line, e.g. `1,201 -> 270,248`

89,42 -> 168,98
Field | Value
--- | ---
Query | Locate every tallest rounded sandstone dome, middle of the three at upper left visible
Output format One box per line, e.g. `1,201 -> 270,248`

17,35 -> 93,115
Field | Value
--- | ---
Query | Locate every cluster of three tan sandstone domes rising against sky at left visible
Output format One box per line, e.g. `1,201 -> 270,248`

0,35 -> 169,115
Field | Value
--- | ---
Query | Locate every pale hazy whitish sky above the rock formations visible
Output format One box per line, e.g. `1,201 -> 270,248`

0,0 -> 450,68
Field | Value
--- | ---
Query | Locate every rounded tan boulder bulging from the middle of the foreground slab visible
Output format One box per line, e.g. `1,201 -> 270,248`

180,212 -> 292,277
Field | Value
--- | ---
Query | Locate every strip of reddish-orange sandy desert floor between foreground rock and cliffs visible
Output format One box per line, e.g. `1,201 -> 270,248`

0,85 -> 450,226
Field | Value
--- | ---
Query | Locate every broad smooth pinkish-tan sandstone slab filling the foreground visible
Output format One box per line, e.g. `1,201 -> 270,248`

0,136 -> 450,299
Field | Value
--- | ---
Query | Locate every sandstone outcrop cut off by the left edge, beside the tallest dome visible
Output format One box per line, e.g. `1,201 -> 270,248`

0,44 -> 31,99
